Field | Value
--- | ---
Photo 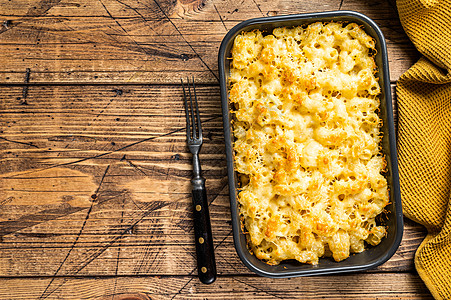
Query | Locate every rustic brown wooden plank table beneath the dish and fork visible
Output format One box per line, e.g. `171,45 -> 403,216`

0,0 -> 431,299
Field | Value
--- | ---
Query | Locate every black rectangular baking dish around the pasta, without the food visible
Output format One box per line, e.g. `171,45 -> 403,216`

219,11 -> 403,277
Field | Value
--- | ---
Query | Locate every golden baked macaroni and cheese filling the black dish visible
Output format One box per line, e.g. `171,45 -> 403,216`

229,22 -> 389,265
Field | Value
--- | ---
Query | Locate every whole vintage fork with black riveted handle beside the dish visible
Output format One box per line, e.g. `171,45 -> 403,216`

181,77 -> 216,284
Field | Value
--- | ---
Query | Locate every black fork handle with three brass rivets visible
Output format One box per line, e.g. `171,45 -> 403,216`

191,177 -> 216,284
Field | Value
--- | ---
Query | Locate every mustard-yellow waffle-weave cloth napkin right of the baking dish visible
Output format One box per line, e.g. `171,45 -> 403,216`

397,0 -> 451,299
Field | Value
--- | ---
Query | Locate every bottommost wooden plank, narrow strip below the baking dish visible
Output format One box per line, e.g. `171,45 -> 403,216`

0,273 -> 433,300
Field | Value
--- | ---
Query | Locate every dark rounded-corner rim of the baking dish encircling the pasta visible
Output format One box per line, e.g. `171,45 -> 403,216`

218,11 -> 404,278
